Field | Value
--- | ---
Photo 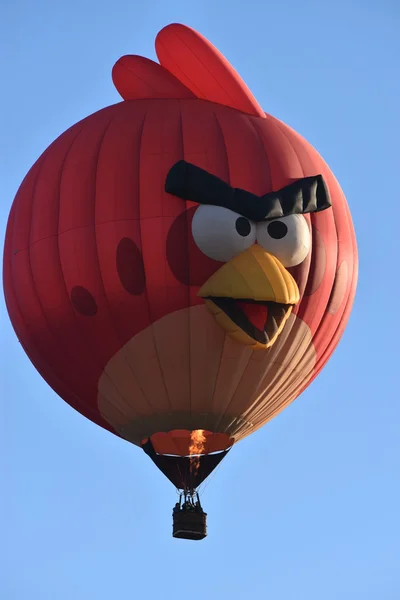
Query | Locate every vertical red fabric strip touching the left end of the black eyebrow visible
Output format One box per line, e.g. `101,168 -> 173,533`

138,100 -> 188,321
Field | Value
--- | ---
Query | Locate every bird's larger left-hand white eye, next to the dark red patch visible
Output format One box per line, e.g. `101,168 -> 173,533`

192,205 -> 256,262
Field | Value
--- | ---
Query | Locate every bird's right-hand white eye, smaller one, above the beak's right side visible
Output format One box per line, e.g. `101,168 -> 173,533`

257,215 -> 311,267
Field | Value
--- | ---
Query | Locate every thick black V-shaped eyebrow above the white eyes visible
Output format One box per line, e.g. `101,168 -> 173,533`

165,160 -> 332,221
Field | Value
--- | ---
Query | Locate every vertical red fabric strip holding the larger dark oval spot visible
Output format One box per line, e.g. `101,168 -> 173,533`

93,102 -> 150,347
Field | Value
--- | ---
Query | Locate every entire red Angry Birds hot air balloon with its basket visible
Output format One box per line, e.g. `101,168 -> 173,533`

4,24 -> 357,539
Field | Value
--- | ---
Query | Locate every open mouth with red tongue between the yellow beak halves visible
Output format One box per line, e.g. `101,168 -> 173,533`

205,296 -> 293,348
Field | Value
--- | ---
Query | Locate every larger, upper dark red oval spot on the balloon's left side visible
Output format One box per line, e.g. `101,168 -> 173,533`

117,238 -> 146,296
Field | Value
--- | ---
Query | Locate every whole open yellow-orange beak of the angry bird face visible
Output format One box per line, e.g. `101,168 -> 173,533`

198,244 -> 300,349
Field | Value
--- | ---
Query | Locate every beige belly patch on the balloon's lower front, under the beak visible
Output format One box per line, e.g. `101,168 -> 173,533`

98,305 -> 315,444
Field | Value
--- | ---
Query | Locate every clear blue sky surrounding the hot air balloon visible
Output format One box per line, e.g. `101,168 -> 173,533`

0,0 -> 400,600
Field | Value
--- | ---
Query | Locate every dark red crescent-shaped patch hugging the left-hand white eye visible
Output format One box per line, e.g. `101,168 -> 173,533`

166,207 -> 223,286
